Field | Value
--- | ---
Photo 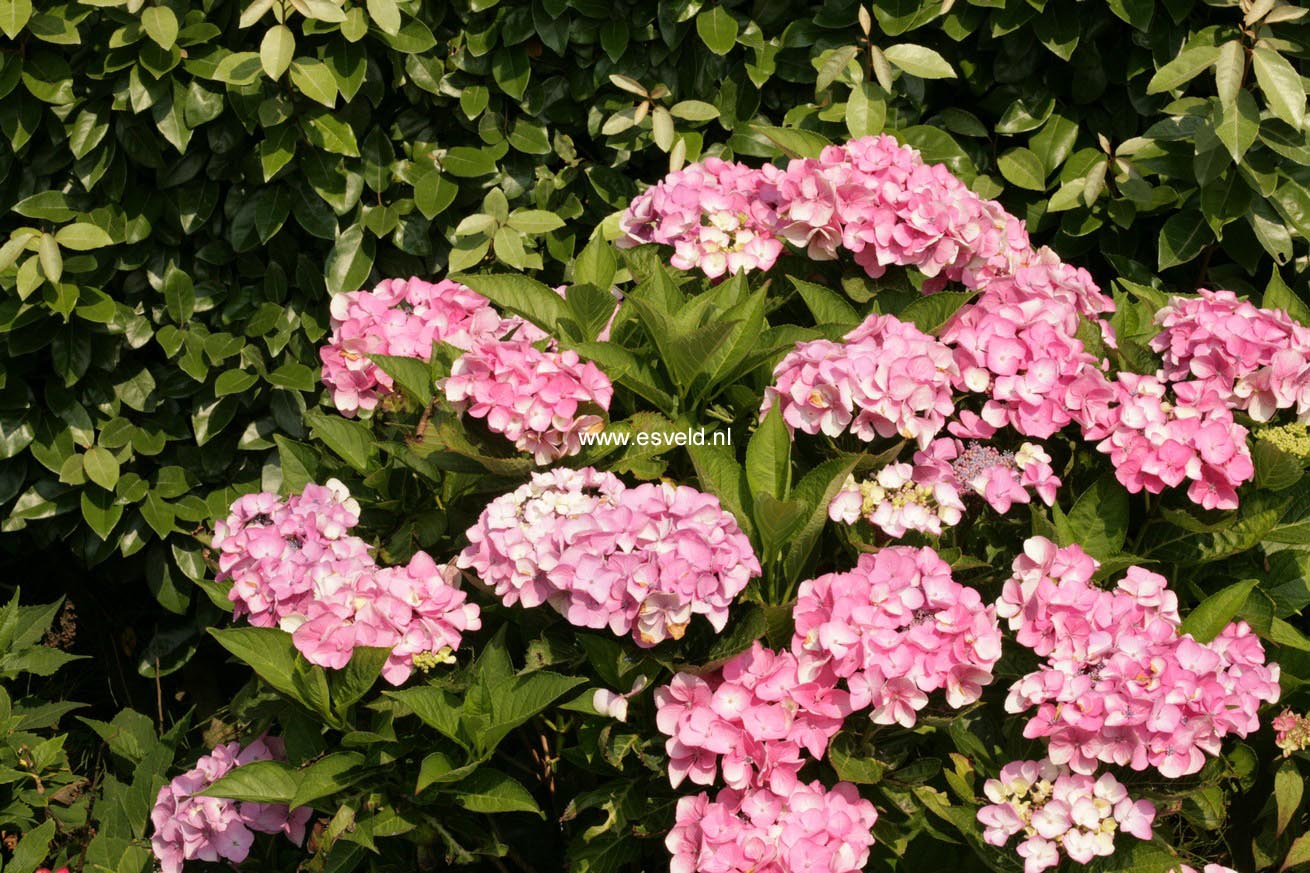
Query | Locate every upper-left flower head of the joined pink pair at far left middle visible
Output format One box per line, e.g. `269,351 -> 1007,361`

212,478 -> 373,628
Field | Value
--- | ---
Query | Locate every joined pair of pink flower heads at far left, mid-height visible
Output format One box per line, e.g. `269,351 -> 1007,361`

214,480 -> 481,686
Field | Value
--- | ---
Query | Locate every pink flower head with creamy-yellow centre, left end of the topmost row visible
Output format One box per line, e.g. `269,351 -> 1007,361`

618,157 -> 782,279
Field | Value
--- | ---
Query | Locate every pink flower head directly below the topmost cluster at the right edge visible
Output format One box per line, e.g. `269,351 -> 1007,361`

1083,372 -> 1255,510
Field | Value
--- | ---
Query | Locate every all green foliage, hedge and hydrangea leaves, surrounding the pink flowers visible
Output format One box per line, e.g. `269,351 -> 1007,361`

0,0 -> 1310,873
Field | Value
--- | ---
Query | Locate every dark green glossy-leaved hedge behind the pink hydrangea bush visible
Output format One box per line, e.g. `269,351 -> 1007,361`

0,0 -> 1310,870
